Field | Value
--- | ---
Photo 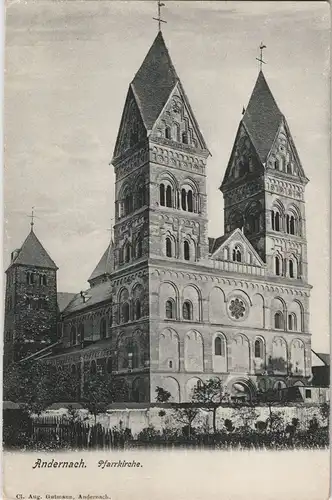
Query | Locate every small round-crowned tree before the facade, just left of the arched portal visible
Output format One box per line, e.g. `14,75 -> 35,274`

192,378 -> 229,432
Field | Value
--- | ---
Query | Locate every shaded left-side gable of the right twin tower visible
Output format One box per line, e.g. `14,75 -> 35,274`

222,122 -> 263,186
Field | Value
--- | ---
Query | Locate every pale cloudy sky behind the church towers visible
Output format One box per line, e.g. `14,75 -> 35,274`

4,0 -> 330,351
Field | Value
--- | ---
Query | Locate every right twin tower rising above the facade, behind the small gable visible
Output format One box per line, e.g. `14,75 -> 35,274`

220,71 -> 308,283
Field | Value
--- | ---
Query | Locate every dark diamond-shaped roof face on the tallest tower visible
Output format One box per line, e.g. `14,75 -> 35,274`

131,31 -> 179,130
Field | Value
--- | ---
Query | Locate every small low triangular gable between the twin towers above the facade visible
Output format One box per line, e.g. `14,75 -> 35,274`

211,229 -> 264,267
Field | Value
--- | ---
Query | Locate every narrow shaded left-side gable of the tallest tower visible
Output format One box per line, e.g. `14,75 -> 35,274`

113,87 -> 146,158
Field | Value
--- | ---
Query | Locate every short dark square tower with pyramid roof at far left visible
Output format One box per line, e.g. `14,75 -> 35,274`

4,224 -> 58,364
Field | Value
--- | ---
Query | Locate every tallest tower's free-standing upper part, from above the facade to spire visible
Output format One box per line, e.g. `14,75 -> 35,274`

112,32 -> 209,268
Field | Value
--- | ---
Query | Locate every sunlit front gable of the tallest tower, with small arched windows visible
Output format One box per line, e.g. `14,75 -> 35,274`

150,82 -> 207,150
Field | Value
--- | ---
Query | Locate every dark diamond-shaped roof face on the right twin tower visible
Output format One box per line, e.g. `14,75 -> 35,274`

242,71 -> 283,163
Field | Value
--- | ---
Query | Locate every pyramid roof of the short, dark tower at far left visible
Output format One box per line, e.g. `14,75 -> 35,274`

10,229 -> 58,270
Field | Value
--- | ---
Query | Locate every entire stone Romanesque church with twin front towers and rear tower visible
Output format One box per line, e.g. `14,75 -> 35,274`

5,31 -> 311,402
